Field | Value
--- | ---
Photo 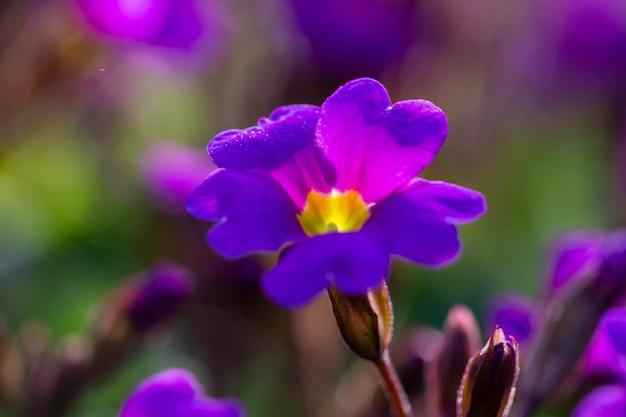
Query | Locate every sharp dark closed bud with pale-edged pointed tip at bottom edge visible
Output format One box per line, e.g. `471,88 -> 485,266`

457,328 -> 519,417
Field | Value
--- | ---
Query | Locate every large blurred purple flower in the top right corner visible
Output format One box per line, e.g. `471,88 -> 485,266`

527,0 -> 626,95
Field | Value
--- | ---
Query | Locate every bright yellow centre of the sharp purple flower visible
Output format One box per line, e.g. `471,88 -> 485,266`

298,190 -> 370,236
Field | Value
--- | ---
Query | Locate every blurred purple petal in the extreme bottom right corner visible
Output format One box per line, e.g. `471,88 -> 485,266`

572,384 -> 626,417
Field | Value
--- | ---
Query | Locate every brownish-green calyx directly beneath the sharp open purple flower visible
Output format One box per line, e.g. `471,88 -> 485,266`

328,281 -> 393,362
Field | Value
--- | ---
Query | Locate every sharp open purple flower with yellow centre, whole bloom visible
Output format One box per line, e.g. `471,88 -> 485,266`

187,79 -> 486,306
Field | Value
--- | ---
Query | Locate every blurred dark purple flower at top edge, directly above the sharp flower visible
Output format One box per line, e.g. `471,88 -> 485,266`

289,0 -> 417,79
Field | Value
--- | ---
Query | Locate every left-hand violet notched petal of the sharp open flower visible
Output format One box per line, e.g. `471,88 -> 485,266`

187,169 -> 305,257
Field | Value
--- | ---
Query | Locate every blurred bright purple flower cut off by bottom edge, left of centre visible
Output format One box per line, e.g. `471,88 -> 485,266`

119,369 -> 244,417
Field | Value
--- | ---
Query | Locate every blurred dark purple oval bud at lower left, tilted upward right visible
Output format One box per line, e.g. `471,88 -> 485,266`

126,263 -> 193,332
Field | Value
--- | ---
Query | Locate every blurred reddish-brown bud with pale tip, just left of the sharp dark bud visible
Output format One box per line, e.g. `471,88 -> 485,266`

426,305 -> 480,417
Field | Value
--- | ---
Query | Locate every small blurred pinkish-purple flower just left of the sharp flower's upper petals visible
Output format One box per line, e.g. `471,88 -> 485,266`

141,142 -> 217,211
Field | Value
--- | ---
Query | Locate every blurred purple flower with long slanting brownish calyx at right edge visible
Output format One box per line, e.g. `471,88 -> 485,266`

508,230 -> 626,413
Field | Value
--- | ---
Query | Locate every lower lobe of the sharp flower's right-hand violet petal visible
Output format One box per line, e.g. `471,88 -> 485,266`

363,193 -> 461,266
